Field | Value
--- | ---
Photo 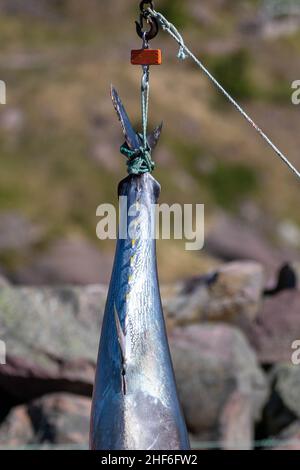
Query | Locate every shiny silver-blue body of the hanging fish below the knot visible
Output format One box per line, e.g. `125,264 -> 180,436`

90,173 -> 190,450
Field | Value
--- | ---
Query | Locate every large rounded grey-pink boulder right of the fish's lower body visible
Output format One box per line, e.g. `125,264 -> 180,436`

170,325 -> 268,449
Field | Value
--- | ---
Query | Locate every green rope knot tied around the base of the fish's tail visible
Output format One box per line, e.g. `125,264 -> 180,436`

120,138 -> 155,175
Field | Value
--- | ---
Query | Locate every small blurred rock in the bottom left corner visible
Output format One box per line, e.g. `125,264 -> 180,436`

0,406 -> 34,447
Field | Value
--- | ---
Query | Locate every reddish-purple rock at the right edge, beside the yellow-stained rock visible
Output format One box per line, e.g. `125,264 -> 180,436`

244,290 -> 300,364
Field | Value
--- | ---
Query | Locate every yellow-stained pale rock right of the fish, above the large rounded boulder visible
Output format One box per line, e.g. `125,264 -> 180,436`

164,262 -> 265,325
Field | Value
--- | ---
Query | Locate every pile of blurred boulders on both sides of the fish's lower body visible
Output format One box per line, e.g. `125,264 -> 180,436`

0,261 -> 300,449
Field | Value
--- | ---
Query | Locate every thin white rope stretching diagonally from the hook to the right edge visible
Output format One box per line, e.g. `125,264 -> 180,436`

147,8 -> 300,178
